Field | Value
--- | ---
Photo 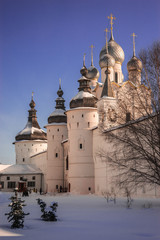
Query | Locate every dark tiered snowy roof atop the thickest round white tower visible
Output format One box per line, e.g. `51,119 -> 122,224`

70,60 -> 97,108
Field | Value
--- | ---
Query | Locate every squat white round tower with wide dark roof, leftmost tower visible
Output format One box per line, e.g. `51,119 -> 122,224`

14,94 -> 47,164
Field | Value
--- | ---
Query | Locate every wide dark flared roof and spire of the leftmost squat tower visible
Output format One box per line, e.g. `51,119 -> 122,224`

15,95 -> 47,141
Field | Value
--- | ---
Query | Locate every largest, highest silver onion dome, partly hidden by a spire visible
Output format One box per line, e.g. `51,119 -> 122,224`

99,38 -> 124,63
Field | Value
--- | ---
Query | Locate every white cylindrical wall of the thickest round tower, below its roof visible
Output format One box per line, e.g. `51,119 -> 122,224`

67,107 -> 98,194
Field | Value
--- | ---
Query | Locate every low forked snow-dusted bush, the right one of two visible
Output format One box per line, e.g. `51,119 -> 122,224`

37,198 -> 58,222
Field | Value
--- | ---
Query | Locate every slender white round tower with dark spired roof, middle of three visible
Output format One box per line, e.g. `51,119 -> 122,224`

45,81 -> 68,192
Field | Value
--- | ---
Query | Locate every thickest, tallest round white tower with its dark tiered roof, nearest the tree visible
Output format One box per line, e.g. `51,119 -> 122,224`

66,58 -> 98,194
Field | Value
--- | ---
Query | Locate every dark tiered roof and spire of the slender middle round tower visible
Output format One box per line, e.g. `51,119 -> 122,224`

48,82 -> 67,123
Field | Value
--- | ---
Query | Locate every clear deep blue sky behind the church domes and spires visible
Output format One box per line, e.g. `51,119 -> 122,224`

0,0 -> 160,164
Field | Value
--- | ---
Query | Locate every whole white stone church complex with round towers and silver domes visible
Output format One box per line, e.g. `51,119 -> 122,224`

0,15 -> 160,196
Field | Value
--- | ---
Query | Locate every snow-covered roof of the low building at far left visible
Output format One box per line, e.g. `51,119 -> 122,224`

0,164 -> 42,175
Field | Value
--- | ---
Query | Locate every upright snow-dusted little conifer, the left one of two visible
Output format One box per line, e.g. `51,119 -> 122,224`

5,191 -> 29,228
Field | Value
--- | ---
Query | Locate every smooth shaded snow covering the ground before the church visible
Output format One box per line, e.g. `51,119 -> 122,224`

0,192 -> 160,240
